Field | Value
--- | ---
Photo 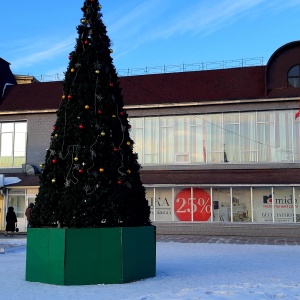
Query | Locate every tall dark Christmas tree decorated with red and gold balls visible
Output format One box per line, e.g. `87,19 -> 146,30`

31,0 -> 151,228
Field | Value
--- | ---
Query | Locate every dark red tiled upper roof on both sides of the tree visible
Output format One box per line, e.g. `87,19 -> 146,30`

0,66 -> 266,111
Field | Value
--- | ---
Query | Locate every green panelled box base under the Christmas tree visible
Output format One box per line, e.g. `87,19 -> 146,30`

26,226 -> 156,285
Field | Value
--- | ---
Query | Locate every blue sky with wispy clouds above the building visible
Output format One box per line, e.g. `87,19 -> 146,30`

0,0 -> 300,79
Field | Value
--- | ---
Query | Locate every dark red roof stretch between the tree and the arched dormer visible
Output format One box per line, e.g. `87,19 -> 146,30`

120,66 -> 265,105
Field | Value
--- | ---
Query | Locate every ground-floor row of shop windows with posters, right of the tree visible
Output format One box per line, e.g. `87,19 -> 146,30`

146,185 -> 300,223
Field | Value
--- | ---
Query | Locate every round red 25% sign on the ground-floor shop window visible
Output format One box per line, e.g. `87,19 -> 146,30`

174,188 -> 211,221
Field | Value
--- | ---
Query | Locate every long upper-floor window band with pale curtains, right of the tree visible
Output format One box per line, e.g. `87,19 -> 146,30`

130,110 -> 300,165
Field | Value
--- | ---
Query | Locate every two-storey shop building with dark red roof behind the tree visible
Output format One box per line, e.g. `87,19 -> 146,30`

0,41 -> 300,230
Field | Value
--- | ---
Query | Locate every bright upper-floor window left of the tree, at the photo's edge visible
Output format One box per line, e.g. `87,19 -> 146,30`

0,122 -> 27,167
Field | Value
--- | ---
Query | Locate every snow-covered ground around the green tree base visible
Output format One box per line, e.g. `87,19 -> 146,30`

0,238 -> 300,300
